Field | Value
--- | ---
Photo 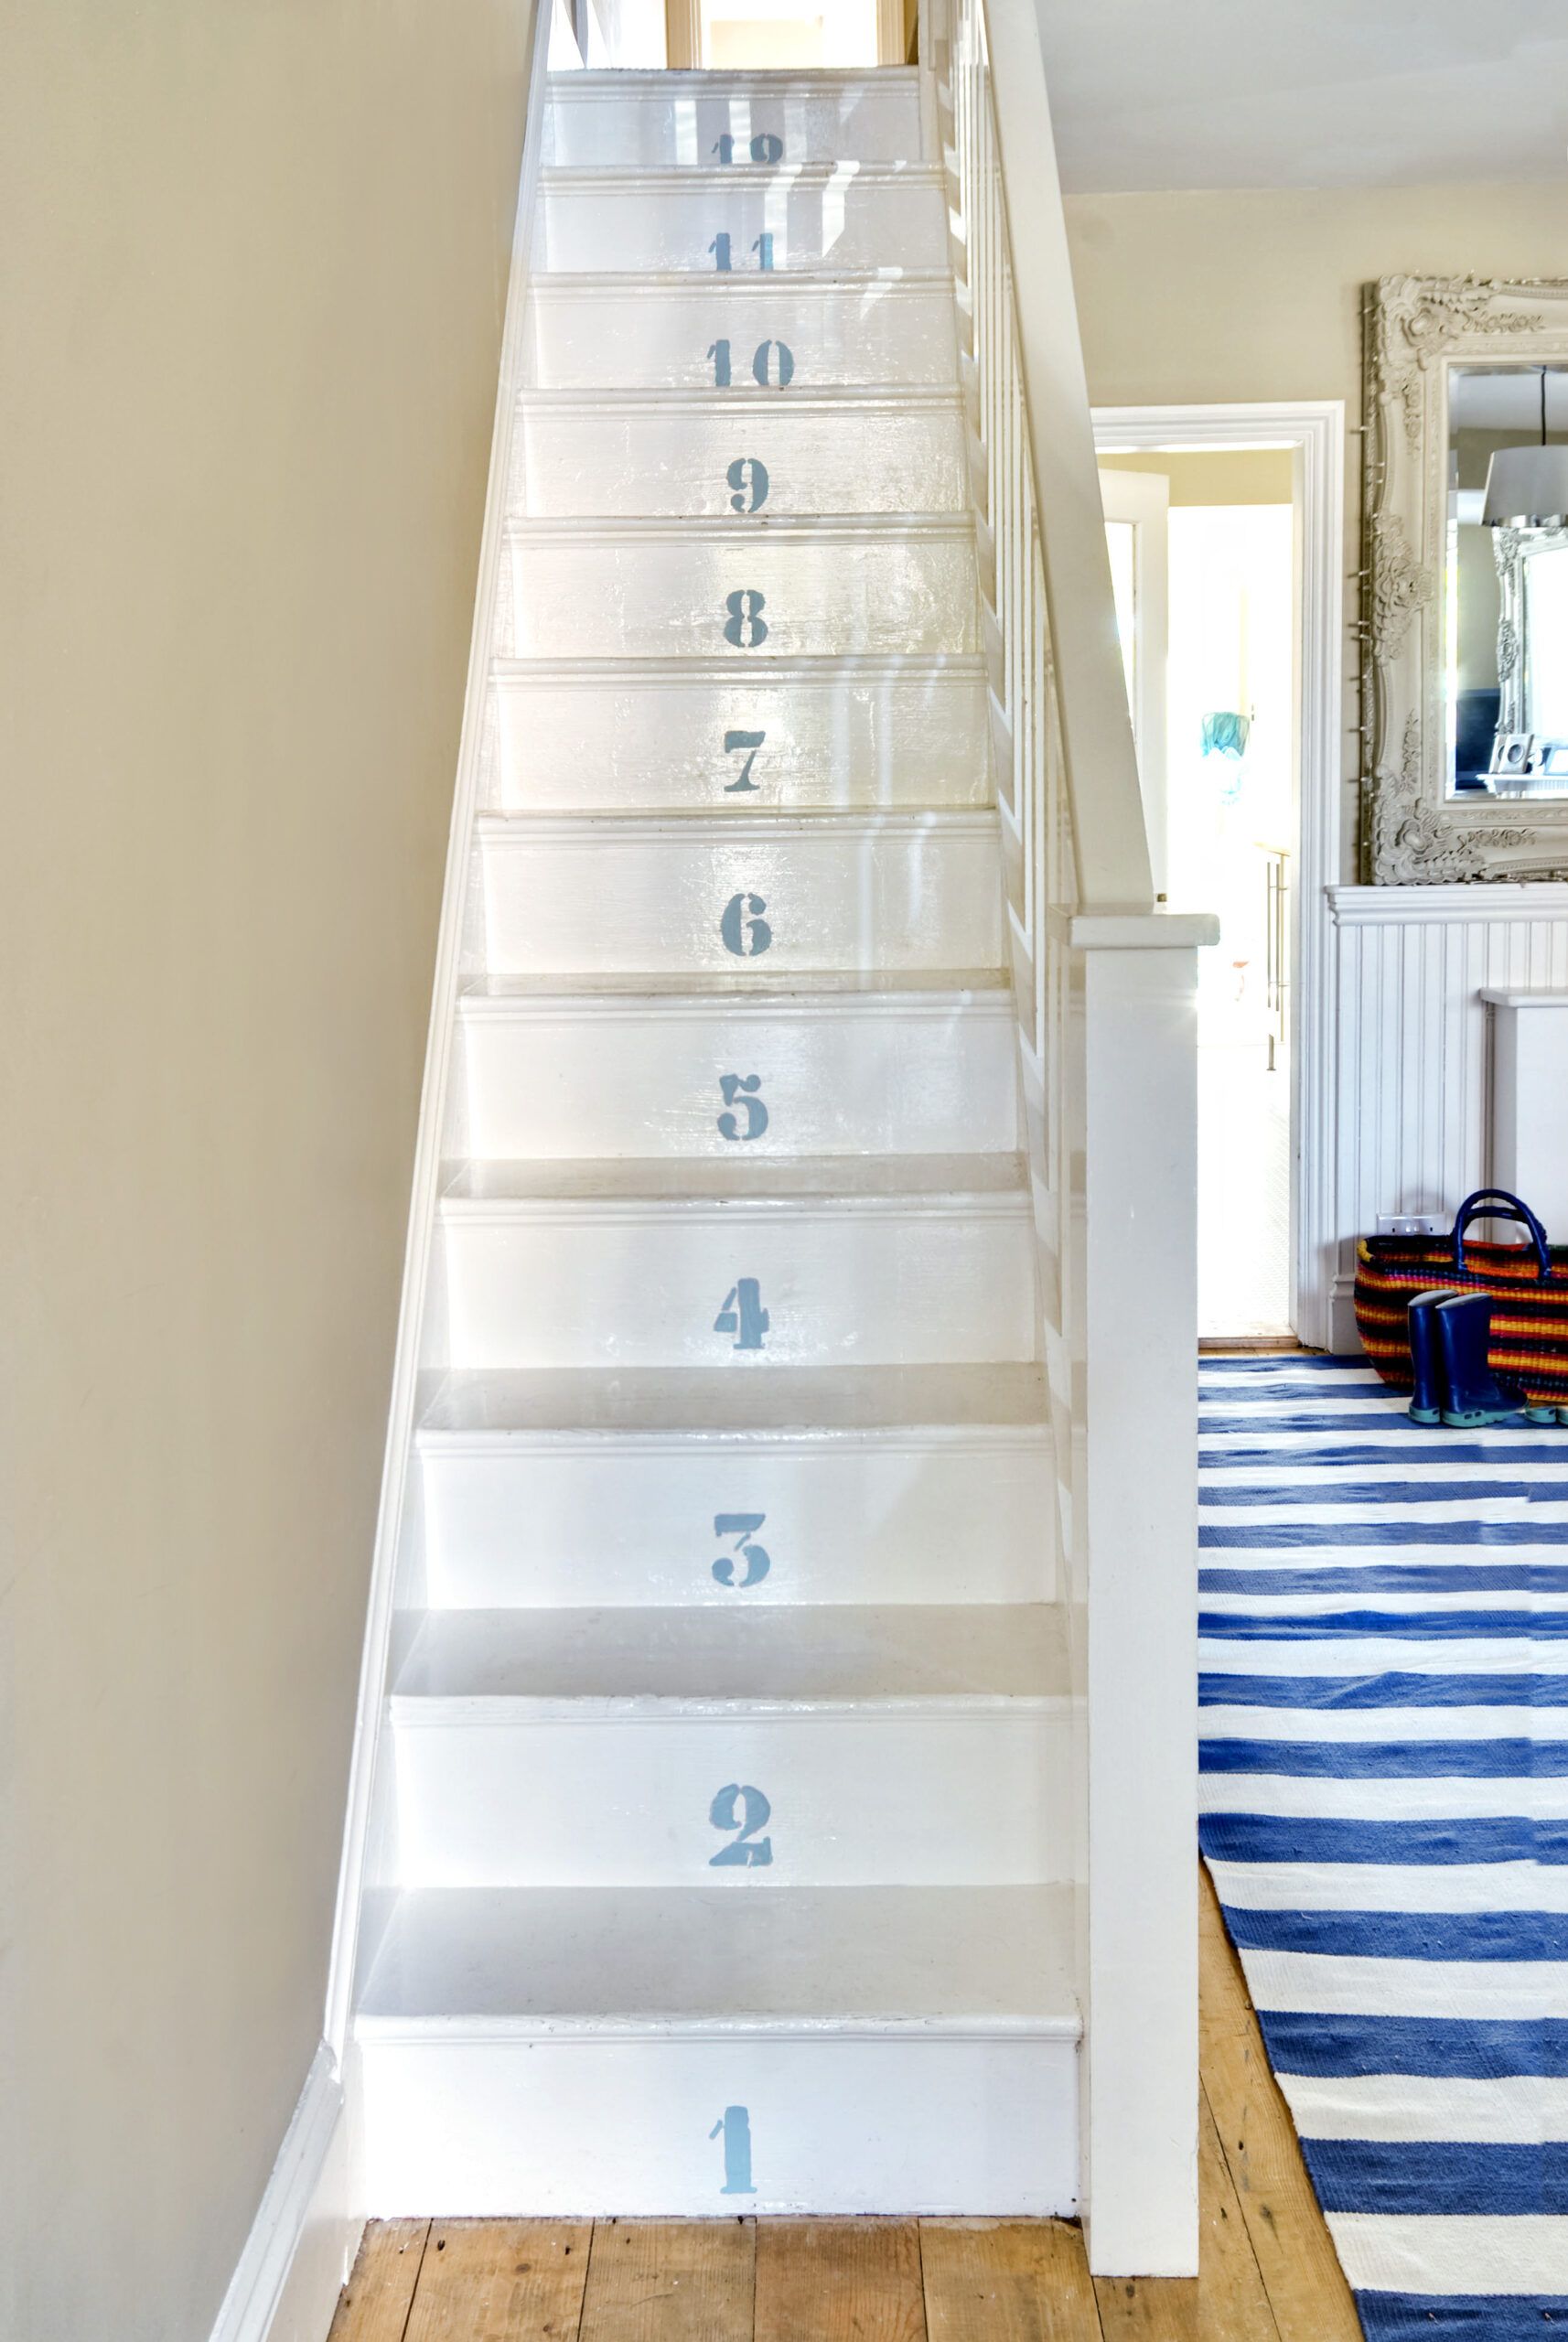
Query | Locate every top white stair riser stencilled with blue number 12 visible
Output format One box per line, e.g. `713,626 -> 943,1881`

545,80 -> 919,171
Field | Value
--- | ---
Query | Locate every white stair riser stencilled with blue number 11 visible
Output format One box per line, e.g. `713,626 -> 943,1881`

538,171 -> 948,276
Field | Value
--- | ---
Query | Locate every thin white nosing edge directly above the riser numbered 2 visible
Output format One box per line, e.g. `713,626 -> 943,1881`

386,1691 -> 1079,1733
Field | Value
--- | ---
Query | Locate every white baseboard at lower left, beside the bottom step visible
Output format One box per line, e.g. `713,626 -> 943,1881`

210,2042 -> 363,2342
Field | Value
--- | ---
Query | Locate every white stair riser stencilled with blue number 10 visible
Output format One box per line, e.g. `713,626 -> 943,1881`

527,274 -> 957,398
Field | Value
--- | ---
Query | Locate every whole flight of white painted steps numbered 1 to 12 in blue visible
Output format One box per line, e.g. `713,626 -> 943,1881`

337,0 -> 1217,2265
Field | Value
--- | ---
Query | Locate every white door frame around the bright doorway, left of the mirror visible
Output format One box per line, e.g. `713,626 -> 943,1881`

1095,398 -> 1346,1349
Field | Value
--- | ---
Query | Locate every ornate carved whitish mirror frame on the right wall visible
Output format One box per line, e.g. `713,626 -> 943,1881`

1359,276 -> 1568,886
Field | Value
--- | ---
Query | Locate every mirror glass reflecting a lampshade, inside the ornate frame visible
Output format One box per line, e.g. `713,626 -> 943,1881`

1446,365 -> 1568,796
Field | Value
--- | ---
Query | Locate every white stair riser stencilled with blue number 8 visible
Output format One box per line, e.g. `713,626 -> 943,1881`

508,536 -> 981,670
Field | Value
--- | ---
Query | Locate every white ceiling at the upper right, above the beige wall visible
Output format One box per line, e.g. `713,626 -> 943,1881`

1036,0 -> 1568,190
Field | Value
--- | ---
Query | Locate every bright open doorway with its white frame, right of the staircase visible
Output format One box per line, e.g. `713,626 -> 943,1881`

1095,405 -> 1343,1347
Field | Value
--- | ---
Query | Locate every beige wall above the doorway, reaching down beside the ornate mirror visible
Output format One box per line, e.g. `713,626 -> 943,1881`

1068,180 -> 1568,876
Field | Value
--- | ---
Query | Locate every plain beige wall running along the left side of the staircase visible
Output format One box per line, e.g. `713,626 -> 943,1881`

0,0 -> 527,2342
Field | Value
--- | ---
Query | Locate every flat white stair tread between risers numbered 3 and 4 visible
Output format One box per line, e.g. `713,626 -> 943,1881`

419,1360 -> 1048,1438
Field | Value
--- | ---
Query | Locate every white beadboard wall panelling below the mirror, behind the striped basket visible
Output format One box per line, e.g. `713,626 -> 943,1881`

1329,886 -> 1568,1349
